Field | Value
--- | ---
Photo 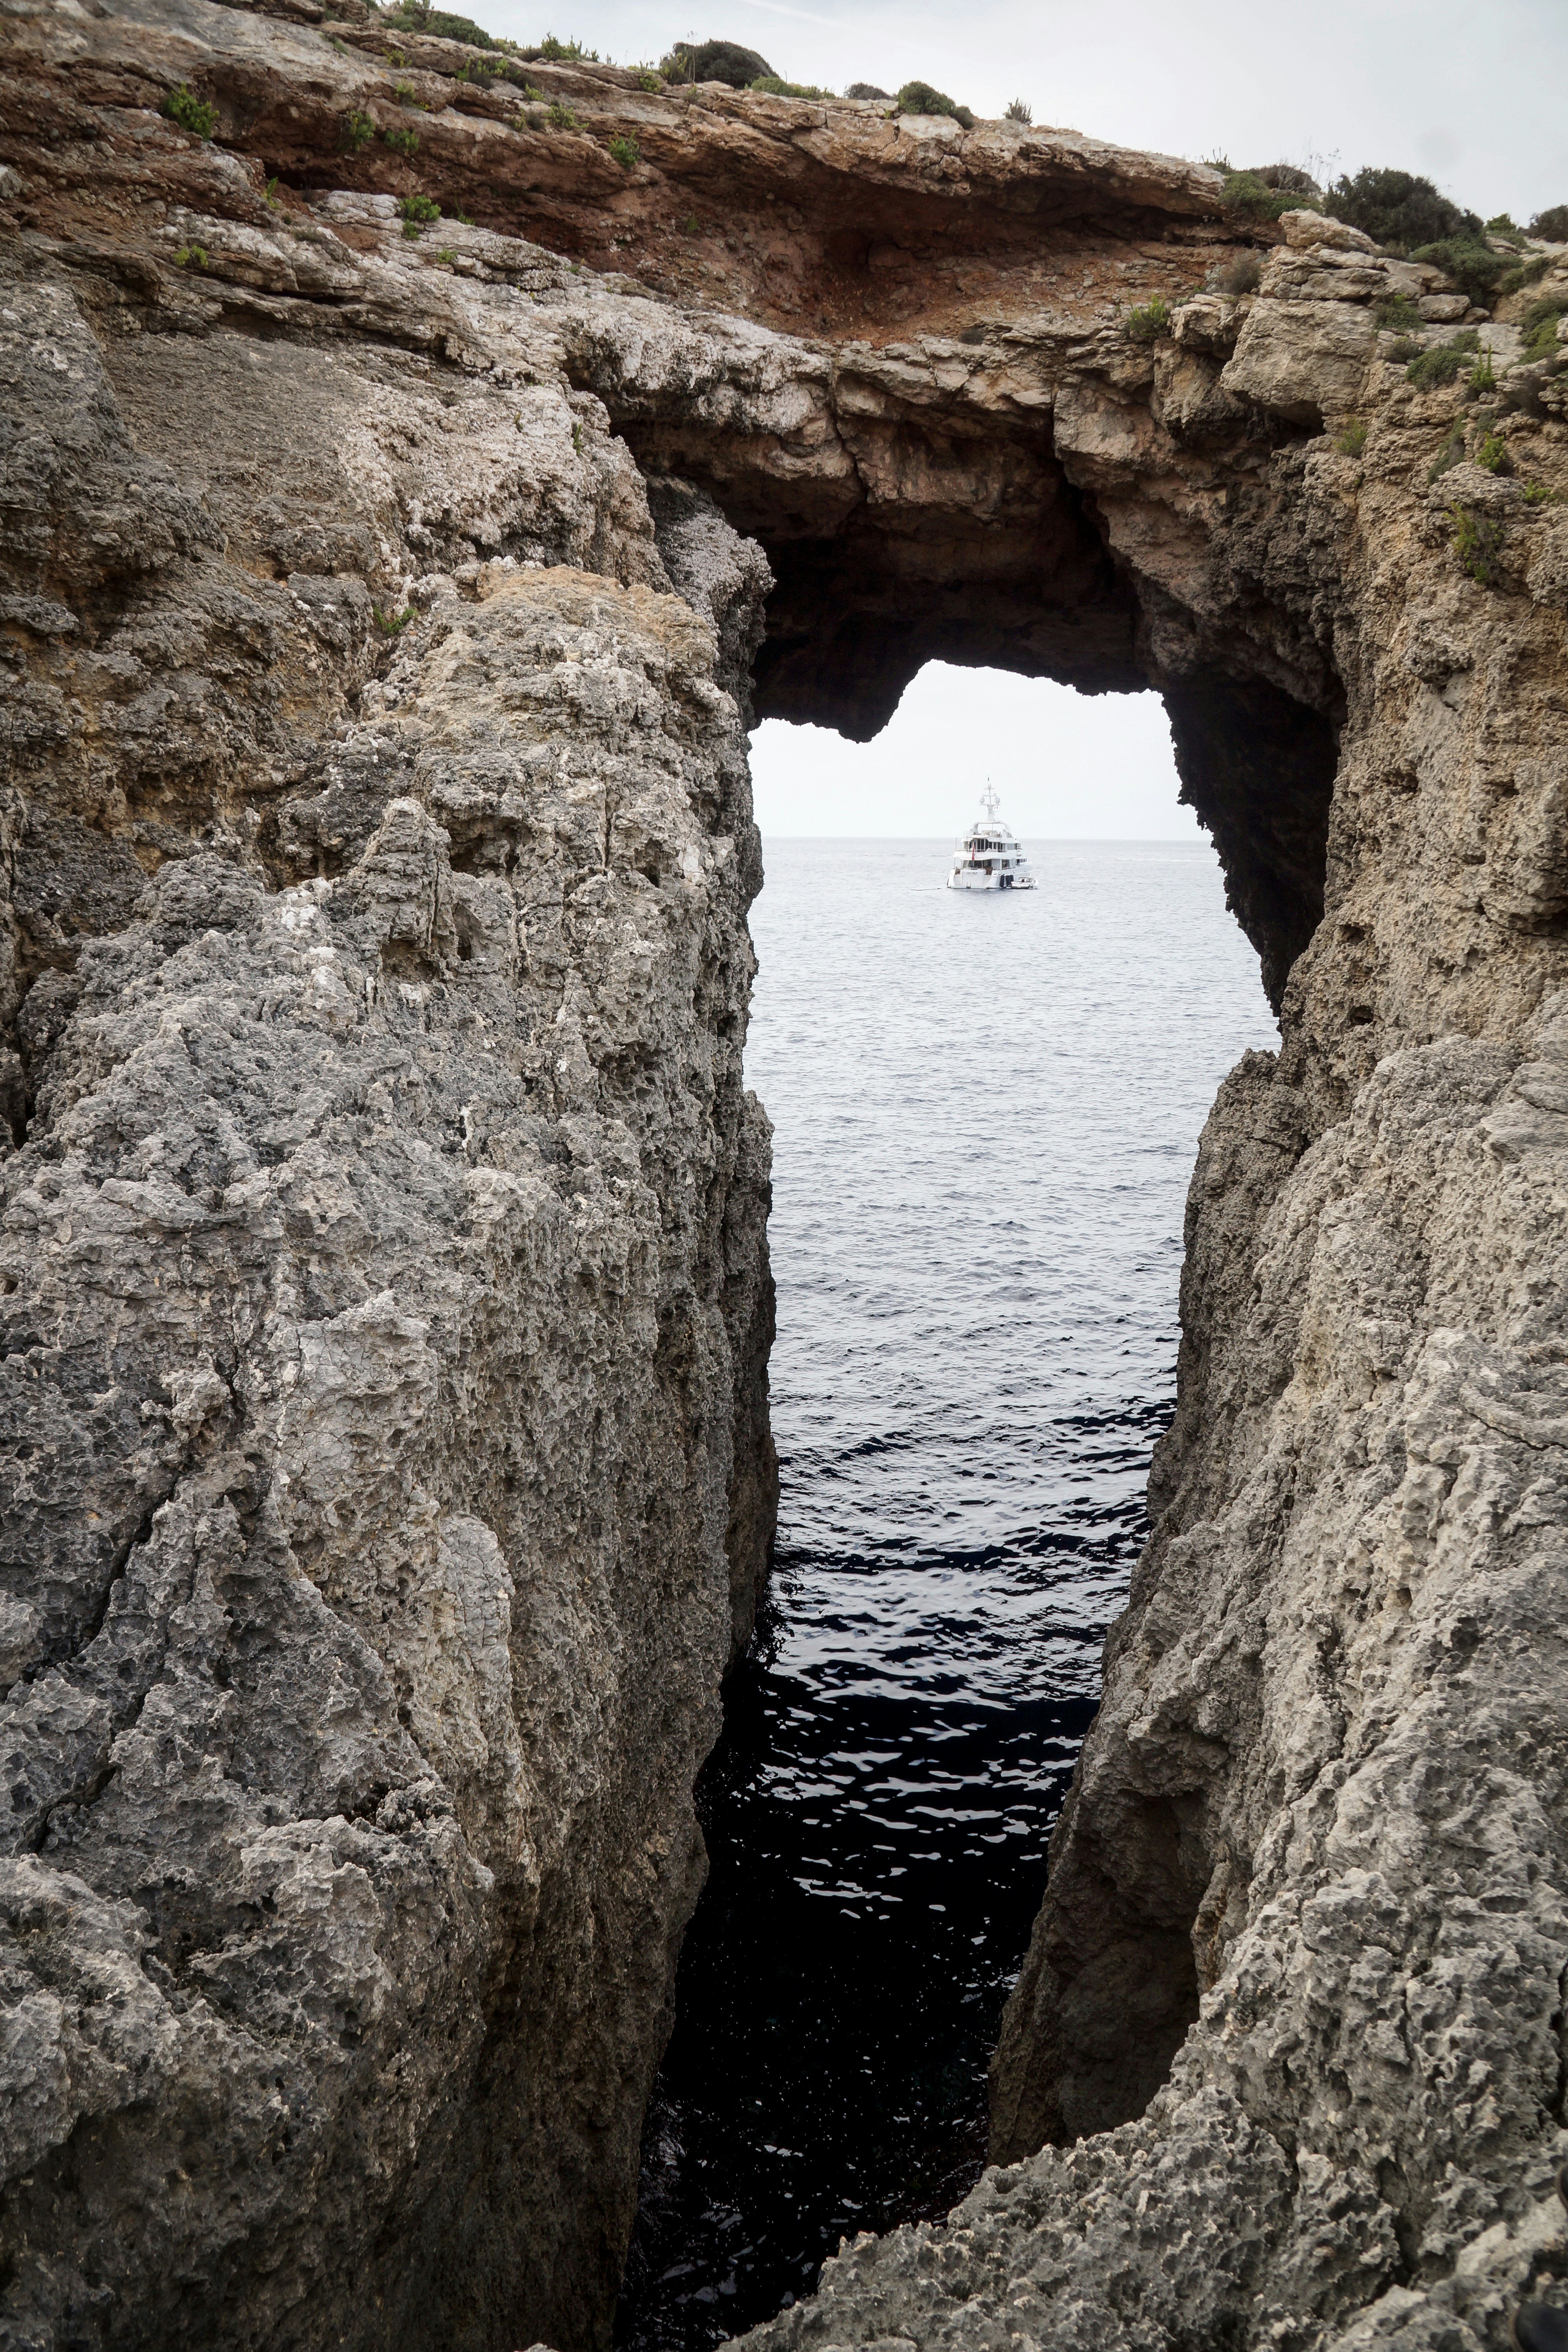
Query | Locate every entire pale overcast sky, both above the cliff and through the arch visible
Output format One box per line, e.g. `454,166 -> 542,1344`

482,0 -> 1568,840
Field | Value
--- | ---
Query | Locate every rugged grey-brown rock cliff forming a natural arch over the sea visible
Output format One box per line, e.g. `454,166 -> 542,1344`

0,0 -> 1568,2352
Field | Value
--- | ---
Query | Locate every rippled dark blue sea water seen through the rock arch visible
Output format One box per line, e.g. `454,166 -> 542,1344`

618,840 -> 1276,2352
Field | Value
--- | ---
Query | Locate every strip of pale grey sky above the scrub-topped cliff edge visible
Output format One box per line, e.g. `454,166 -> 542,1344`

482,0 -> 1568,221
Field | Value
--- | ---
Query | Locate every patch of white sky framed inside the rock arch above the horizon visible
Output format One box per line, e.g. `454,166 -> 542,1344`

752,661 -> 1199,847
